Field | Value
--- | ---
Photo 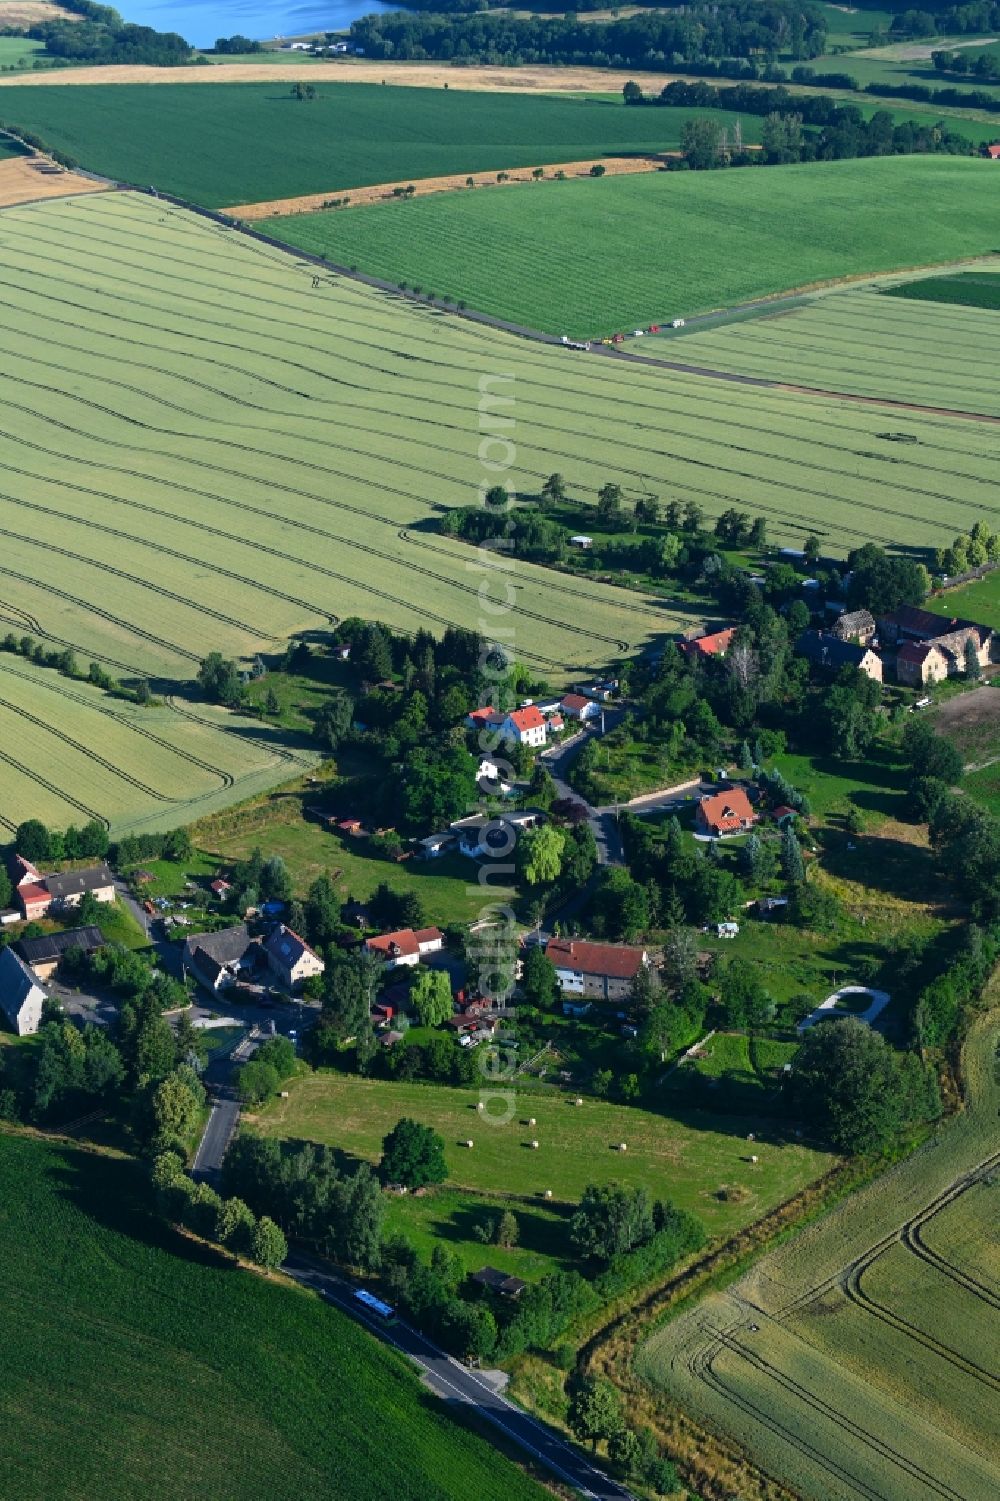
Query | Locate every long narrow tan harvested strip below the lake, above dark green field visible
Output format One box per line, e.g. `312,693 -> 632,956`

0,59 -> 673,93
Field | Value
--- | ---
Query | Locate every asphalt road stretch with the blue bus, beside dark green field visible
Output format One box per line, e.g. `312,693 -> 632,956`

284,1255 -> 635,1501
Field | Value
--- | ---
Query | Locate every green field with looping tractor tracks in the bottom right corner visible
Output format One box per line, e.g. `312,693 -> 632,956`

637,985 -> 1000,1501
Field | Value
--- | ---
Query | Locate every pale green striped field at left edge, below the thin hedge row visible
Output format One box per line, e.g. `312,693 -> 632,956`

0,648 -> 315,833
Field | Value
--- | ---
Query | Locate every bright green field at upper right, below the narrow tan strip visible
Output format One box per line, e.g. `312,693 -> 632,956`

267,153 -> 997,336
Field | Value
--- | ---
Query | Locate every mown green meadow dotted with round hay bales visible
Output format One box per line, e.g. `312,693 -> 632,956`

254,1072 -> 830,1235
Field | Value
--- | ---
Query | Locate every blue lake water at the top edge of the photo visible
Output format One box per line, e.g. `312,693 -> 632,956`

117,0 -> 401,47
